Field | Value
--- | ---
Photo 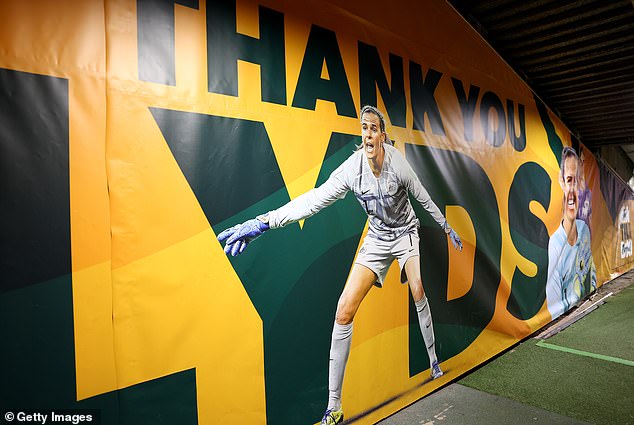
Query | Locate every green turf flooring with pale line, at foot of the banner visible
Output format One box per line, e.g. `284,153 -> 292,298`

460,286 -> 634,425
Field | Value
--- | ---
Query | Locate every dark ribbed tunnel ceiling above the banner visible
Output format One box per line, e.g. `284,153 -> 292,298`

448,0 -> 634,162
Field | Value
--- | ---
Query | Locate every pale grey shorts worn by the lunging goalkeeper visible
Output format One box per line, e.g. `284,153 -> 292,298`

355,231 -> 420,288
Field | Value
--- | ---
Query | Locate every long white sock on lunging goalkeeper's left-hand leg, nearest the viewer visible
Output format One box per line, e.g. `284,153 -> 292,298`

328,322 -> 352,410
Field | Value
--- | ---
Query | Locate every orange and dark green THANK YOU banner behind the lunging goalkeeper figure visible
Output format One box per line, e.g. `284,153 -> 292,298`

0,0 -> 634,425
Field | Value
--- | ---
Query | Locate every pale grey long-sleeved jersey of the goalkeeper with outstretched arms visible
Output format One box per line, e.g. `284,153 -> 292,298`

268,143 -> 448,241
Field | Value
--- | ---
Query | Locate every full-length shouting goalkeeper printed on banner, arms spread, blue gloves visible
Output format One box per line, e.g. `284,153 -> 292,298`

218,106 -> 462,425
